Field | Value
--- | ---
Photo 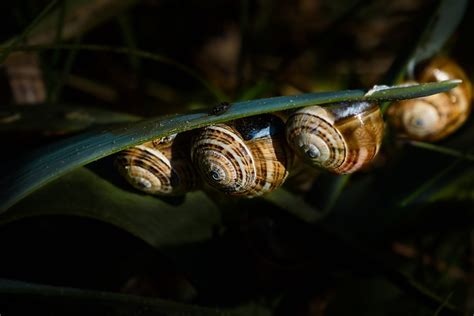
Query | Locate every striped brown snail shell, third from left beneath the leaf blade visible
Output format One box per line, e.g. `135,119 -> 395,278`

286,102 -> 384,174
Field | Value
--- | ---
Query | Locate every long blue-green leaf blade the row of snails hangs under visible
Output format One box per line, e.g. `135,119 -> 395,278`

0,80 -> 459,211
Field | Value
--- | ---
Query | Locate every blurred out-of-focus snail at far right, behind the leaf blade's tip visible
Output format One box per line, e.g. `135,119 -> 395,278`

387,57 -> 472,141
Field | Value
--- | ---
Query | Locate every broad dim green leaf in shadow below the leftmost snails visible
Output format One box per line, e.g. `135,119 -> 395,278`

0,162 -> 220,247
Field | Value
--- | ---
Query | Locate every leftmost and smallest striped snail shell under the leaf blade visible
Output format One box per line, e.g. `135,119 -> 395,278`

115,134 -> 198,195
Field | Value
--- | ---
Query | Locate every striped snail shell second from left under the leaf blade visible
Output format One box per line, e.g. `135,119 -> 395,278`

191,114 -> 293,197
